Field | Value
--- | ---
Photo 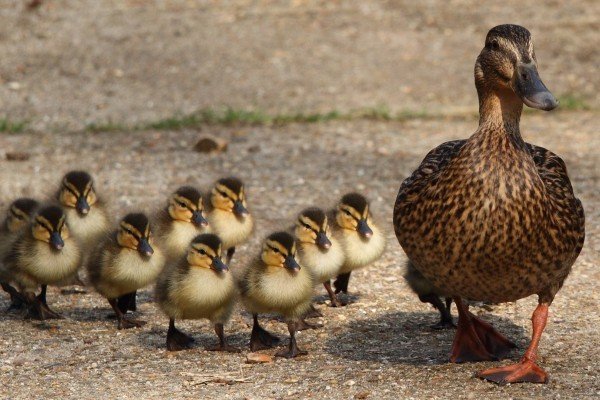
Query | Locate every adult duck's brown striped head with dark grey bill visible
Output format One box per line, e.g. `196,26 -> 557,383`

475,24 -> 558,111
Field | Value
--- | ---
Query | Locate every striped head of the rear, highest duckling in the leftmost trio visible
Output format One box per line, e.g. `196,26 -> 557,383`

58,171 -> 98,216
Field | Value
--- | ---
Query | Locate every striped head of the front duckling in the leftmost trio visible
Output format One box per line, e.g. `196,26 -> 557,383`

31,206 -> 69,251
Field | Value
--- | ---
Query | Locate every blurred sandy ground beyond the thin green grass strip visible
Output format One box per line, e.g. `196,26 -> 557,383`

0,0 -> 600,130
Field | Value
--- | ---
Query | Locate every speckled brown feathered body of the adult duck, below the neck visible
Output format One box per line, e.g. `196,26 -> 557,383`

394,134 -> 585,302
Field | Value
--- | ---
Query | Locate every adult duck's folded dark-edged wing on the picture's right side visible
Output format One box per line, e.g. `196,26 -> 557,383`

527,143 -> 585,257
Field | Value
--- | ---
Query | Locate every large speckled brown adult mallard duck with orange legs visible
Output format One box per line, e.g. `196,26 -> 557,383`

394,25 -> 585,384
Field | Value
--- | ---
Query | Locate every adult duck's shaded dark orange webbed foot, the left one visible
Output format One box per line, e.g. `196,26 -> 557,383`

450,297 -> 516,363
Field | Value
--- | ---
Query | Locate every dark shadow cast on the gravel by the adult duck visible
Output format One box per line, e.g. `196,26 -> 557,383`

325,312 -> 529,365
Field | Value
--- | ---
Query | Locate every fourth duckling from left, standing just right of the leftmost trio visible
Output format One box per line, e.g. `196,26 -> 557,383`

87,213 -> 165,329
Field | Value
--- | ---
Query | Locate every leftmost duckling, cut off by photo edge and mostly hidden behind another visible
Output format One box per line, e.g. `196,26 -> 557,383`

0,197 -> 39,310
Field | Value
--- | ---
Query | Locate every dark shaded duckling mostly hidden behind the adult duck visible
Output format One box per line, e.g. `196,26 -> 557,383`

404,260 -> 456,330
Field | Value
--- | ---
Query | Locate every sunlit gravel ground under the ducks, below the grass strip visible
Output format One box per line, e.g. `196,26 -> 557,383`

0,113 -> 600,399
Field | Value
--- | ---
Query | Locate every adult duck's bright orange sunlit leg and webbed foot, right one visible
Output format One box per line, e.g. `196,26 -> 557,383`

477,303 -> 548,385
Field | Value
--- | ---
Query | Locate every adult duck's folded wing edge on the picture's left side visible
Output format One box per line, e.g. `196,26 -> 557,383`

396,139 -> 467,207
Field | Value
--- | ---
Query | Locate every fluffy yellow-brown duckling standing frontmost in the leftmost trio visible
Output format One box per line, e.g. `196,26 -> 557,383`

4,205 -> 81,320
